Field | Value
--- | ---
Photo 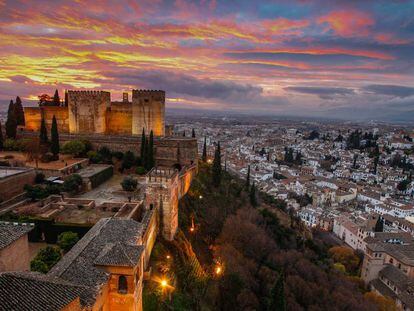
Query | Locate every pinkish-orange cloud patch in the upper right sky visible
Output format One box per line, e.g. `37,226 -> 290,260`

317,10 -> 375,37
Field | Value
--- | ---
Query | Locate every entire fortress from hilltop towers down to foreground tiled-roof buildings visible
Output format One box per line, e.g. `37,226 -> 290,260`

0,90 -> 198,311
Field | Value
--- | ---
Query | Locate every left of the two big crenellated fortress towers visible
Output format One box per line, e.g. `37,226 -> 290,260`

68,91 -> 111,134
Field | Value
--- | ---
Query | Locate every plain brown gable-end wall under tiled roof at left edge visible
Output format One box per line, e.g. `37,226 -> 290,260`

0,234 -> 30,272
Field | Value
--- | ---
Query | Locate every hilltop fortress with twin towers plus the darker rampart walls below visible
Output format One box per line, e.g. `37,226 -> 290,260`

21,90 -> 198,167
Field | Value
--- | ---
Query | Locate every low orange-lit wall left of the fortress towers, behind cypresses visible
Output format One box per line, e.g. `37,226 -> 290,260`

24,106 -> 69,133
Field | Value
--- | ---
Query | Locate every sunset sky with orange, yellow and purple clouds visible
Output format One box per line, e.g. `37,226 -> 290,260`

0,0 -> 414,119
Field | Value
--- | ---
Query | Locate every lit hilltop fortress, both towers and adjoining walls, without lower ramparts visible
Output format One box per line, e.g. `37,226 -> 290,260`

25,90 -> 165,137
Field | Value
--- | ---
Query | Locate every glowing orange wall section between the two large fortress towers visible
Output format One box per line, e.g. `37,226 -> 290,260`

106,102 -> 132,135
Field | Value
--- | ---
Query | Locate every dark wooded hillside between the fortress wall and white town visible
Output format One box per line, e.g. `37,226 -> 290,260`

144,164 -> 378,310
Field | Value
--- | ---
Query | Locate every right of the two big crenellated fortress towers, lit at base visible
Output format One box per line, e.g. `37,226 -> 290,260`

132,90 -> 165,136
